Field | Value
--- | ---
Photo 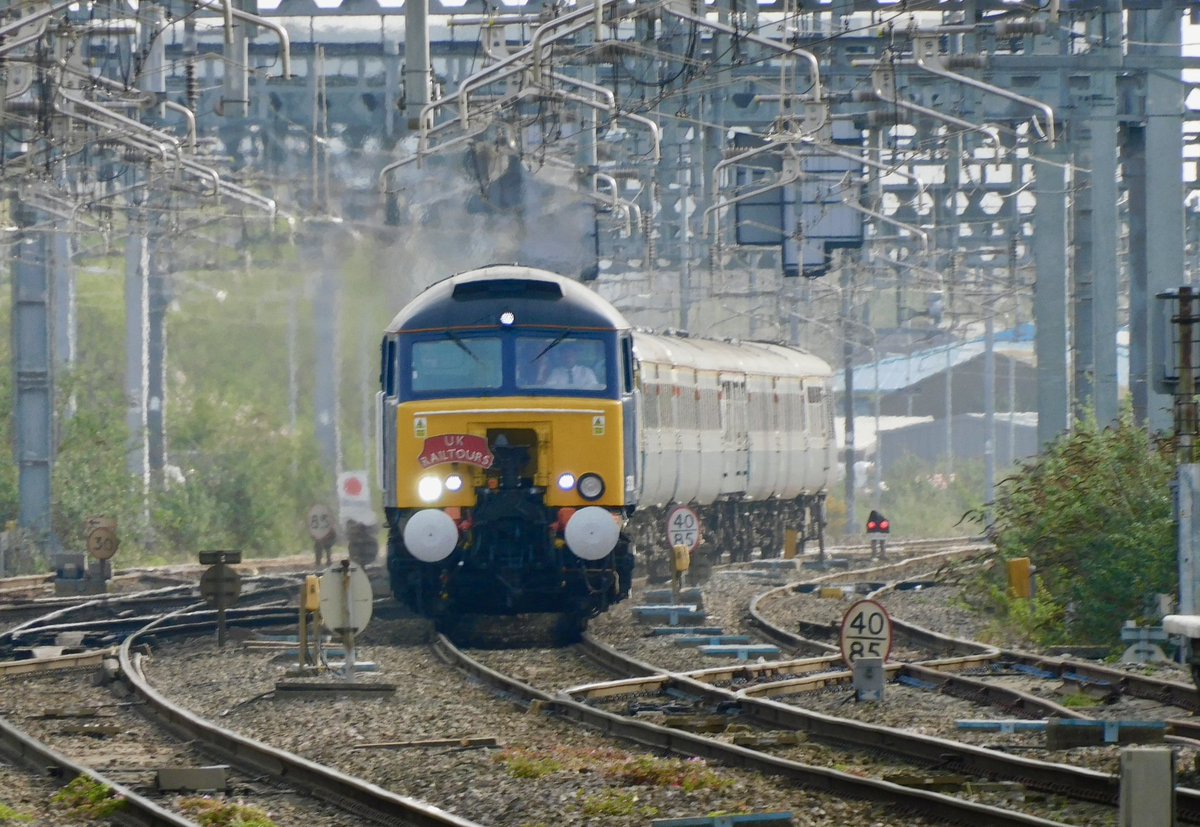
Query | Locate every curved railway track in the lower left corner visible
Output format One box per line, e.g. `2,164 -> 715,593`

0,578 -> 478,827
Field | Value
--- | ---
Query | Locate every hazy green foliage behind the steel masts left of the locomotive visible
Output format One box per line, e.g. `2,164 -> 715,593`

0,222 -> 379,570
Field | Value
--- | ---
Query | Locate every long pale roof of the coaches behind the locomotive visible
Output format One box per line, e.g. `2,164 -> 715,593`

634,330 -> 833,377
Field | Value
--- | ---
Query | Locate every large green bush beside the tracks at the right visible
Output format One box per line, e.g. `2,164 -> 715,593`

972,410 -> 1177,647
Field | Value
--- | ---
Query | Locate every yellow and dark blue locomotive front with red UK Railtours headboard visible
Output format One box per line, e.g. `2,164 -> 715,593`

380,266 -> 637,619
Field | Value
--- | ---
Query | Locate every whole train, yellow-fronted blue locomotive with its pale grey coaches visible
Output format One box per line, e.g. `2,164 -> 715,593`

379,265 -> 834,628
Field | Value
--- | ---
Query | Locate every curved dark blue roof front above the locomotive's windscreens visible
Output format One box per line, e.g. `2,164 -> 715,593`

386,264 -> 629,334
